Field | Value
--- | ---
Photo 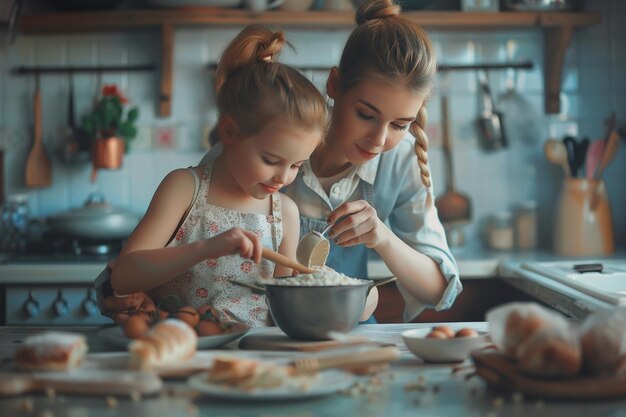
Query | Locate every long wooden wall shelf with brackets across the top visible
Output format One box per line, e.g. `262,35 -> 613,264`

19,7 -> 601,116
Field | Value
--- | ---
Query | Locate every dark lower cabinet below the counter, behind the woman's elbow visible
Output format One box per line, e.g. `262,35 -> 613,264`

374,277 -> 537,323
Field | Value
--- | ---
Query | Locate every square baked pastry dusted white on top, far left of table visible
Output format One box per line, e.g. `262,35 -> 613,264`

15,332 -> 87,371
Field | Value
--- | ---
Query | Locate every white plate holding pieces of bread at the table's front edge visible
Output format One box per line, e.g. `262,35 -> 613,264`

188,369 -> 356,401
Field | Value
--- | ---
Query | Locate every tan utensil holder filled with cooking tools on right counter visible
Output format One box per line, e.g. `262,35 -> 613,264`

554,178 -> 614,256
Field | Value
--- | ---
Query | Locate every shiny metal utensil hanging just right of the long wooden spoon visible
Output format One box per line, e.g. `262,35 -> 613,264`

478,70 -> 507,150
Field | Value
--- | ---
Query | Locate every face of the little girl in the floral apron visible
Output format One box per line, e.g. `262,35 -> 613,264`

225,122 -> 323,200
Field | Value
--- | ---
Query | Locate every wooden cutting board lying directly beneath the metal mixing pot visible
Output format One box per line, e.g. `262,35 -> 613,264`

239,327 -> 379,352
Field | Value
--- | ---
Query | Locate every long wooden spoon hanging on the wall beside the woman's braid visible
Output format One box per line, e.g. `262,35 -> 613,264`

435,88 -> 472,223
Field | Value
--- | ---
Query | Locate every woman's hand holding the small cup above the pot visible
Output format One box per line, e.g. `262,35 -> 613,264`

328,200 -> 391,249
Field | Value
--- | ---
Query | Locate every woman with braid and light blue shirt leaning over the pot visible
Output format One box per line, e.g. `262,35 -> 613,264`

285,0 -> 462,321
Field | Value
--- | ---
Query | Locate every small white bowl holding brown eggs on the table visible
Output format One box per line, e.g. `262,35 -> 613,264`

402,327 -> 491,362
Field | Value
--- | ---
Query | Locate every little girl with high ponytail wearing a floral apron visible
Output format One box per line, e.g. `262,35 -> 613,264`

106,26 -> 327,326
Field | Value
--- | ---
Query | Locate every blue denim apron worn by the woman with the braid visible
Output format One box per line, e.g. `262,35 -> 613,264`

300,182 -> 376,323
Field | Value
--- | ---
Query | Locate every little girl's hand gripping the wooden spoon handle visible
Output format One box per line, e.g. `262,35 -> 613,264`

207,227 -> 263,264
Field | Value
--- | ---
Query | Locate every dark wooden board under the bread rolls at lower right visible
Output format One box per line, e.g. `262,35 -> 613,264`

471,351 -> 626,401
